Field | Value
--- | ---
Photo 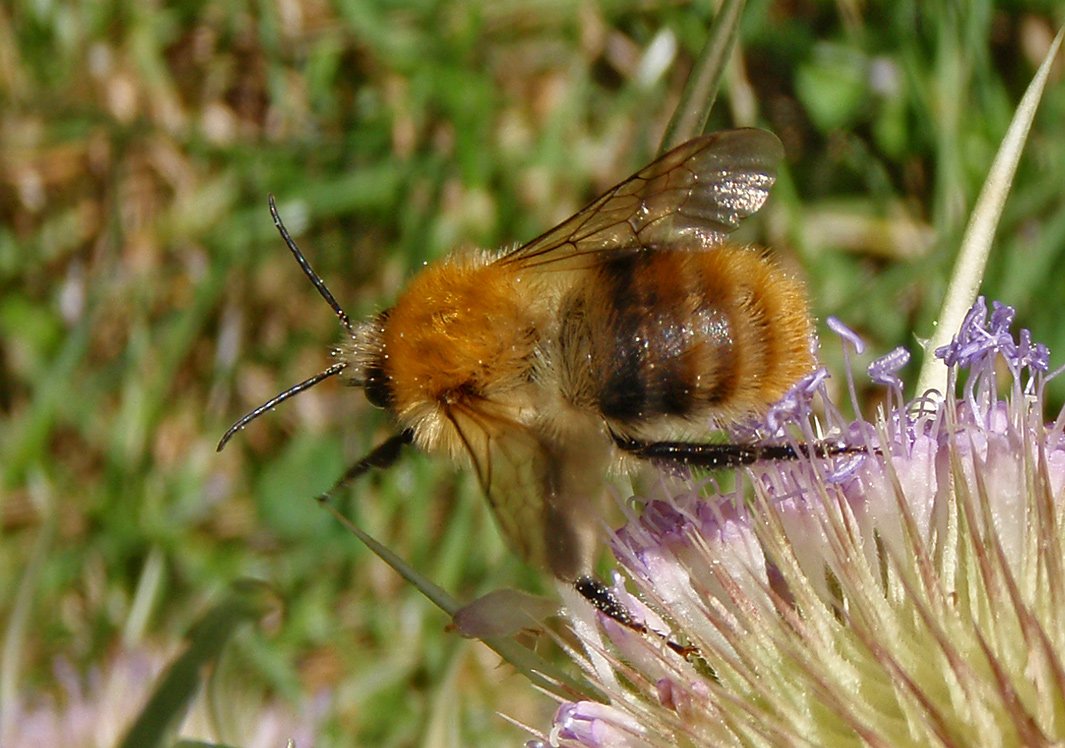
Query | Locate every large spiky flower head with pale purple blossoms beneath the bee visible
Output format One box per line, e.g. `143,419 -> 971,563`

529,299 -> 1065,747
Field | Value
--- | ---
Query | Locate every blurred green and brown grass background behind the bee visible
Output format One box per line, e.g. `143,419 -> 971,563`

6,0 -> 1065,746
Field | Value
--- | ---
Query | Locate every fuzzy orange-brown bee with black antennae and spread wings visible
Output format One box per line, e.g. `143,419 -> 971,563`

218,129 -> 823,588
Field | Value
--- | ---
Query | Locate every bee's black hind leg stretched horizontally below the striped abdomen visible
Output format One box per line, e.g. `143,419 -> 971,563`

611,433 -> 866,470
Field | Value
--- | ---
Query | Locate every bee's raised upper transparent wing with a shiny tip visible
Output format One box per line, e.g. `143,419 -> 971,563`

498,129 -> 784,267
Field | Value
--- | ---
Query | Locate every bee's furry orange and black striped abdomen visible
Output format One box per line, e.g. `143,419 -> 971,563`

559,245 -> 813,433
